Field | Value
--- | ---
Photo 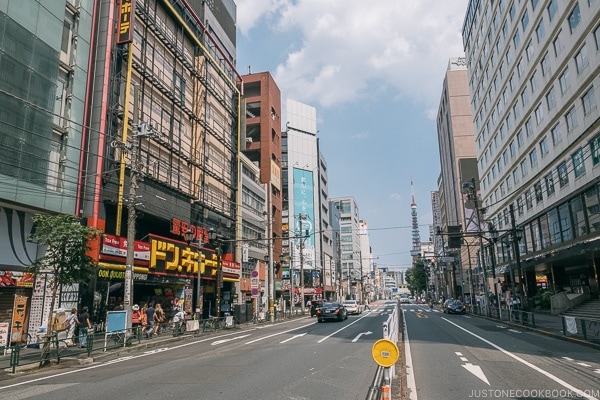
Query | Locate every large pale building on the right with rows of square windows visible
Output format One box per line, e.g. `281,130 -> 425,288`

463,0 -> 600,301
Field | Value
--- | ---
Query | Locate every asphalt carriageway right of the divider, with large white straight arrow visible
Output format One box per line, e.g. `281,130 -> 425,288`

402,304 -> 600,400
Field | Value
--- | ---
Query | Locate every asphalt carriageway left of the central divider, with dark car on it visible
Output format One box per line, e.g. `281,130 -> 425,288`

0,305 -> 398,400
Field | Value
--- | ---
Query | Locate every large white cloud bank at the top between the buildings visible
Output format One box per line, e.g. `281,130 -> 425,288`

238,0 -> 467,115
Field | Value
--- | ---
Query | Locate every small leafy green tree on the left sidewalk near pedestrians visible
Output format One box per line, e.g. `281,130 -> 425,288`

28,214 -> 100,332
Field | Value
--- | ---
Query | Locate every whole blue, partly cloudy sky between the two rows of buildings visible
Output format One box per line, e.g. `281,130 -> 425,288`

235,0 -> 468,267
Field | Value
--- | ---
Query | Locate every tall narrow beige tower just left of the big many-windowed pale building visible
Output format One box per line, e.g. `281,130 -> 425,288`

434,57 -> 481,297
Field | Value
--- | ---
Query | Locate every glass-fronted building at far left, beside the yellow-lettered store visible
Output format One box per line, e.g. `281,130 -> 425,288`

0,0 -> 96,324
